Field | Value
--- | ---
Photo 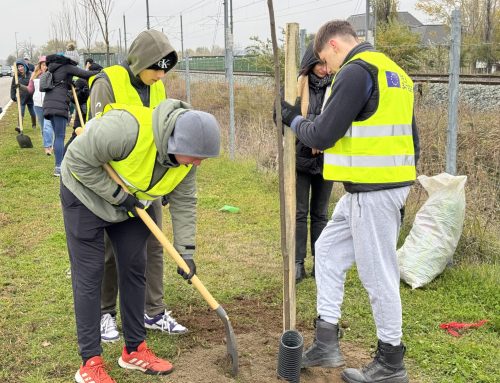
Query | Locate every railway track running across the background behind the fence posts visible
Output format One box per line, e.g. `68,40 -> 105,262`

176,69 -> 500,85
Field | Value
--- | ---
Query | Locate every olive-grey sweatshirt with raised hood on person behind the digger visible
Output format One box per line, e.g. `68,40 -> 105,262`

89,29 -> 177,119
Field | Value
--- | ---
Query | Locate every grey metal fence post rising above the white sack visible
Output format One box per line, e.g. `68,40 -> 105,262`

446,9 -> 461,175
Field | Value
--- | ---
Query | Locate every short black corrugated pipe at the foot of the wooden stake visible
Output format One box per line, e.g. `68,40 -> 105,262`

278,330 -> 304,383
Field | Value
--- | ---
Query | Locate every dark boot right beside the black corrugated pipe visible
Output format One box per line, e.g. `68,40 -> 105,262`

301,318 -> 345,368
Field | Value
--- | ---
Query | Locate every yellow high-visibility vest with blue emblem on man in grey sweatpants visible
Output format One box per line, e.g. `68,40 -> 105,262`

323,52 -> 416,184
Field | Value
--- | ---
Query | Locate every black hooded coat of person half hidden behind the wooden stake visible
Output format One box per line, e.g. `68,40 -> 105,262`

295,43 -> 332,175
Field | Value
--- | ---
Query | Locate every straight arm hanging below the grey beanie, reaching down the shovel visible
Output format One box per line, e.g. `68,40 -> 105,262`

168,165 -> 197,259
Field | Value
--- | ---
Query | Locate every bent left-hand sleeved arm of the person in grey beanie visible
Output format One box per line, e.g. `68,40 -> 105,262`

64,110 -> 139,205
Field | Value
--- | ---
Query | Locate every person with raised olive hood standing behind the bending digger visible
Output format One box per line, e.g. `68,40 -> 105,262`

88,29 -> 188,342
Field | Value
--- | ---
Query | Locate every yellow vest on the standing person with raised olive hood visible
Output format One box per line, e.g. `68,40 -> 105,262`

87,65 -> 166,118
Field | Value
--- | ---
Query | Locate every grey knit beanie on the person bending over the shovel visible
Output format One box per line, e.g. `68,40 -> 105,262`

167,110 -> 220,158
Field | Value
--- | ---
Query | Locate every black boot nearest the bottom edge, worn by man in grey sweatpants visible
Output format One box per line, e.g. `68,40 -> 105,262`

342,340 -> 409,383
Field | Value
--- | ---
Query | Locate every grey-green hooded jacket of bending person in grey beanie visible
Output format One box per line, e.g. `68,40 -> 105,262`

61,99 -> 197,257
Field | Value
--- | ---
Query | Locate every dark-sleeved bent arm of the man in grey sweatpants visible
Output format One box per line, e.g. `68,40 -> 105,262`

291,63 -> 373,150
